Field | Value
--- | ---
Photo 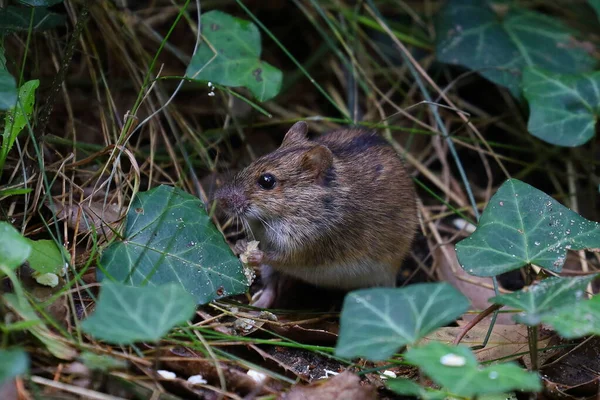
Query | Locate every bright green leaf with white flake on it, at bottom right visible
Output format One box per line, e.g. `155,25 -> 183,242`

404,342 -> 542,397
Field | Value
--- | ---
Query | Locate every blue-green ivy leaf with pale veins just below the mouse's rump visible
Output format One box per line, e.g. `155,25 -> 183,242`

335,283 -> 469,361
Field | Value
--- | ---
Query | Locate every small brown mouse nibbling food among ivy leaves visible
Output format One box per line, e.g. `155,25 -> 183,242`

215,122 -> 418,308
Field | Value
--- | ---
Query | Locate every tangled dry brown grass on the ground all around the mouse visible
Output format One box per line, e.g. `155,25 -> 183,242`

0,0 -> 600,399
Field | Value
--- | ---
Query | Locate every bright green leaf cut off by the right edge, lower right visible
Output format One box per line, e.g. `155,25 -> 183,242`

541,295 -> 600,339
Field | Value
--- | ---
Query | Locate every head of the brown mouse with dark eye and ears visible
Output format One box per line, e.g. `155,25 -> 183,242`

215,121 -> 333,221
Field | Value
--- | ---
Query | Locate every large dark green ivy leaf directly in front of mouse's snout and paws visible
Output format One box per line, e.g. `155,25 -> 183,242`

98,186 -> 248,304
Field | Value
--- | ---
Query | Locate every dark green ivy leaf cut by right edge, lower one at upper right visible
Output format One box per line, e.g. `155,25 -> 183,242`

523,68 -> 600,147
